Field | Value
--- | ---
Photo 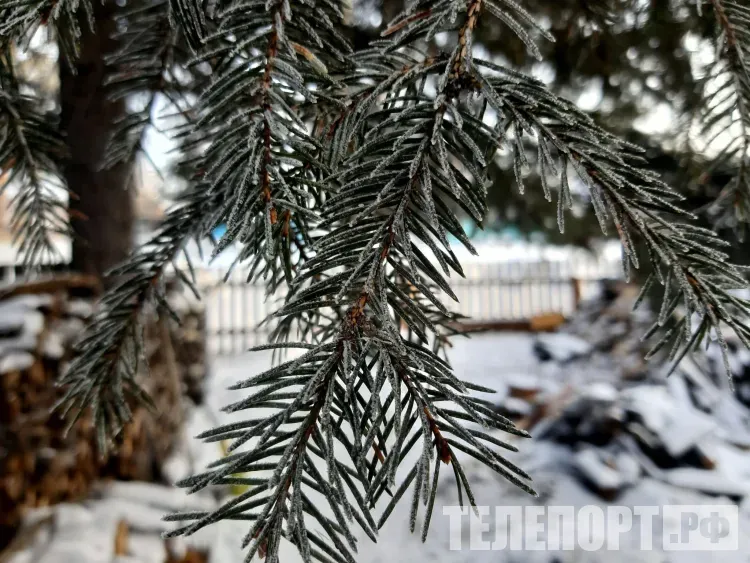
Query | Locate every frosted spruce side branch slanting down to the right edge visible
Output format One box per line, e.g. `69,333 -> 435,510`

476,57 -> 750,375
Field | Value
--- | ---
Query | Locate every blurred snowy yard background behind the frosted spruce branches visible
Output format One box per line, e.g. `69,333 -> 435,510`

0,0 -> 750,563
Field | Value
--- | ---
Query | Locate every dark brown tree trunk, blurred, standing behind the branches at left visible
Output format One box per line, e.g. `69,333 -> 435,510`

60,2 -> 133,277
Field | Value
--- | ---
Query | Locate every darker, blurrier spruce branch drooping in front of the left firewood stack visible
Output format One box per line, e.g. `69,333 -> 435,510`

57,178 -> 221,453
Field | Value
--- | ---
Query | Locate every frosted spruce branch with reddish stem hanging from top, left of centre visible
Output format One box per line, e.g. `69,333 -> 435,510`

191,0 -> 350,283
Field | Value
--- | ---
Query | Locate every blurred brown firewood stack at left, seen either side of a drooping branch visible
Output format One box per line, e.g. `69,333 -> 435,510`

0,276 -> 205,545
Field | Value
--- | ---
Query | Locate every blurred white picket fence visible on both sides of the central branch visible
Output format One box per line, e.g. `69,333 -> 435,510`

198,243 -> 622,355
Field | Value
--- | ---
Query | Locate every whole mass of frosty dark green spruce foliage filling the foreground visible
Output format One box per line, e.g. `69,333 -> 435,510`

4,0 -> 750,562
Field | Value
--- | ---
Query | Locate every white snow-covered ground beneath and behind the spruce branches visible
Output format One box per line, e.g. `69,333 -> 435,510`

10,328 -> 750,563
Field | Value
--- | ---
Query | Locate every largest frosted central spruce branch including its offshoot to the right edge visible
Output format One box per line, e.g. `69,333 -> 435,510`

171,0 -> 750,561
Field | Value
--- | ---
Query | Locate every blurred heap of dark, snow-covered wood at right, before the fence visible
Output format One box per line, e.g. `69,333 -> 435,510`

497,284 -> 750,503
